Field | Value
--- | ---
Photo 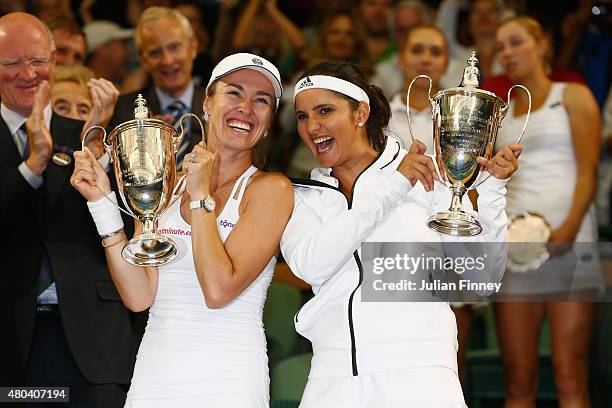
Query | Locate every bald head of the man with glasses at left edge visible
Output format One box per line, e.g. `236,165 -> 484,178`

0,13 -> 55,116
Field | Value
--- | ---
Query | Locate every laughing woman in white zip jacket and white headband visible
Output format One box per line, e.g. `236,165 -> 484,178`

281,62 -> 520,408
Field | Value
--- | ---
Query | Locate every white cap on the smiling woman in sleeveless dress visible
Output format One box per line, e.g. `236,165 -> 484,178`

206,52 -> 283,108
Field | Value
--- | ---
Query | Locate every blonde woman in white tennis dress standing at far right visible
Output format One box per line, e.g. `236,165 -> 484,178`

495,16 -> 603,407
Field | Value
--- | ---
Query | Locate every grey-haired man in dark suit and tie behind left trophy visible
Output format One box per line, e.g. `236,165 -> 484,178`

108,7 -> 204,169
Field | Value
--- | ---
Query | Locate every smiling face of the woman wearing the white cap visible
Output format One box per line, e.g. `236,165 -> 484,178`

204,69 -> 276,151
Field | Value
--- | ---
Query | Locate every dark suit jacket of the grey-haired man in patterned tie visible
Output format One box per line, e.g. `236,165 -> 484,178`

106,85 -> 204,152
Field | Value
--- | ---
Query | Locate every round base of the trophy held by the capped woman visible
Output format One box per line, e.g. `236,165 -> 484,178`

121,234 -> 177,266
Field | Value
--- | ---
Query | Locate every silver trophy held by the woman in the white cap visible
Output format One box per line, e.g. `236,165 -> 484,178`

83,95 -> 205,266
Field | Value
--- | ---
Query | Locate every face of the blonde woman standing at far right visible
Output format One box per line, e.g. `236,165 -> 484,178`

496,21 -> 547,82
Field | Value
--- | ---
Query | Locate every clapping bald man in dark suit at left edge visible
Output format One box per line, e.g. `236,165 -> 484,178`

0,13 -> 137,407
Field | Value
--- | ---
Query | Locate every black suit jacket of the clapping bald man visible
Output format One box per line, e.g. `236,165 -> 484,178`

0,114 -> 138,386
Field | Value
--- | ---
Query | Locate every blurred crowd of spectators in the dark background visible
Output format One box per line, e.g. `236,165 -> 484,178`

0,0 -> 612,190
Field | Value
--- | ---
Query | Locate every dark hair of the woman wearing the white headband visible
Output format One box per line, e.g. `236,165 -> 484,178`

302,61 -> 391,152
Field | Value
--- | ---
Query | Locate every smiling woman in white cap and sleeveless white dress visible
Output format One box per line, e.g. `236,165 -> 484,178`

71,53 -> 293,408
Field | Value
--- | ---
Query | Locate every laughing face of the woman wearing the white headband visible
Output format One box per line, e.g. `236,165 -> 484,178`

295,89 -> 372,168
